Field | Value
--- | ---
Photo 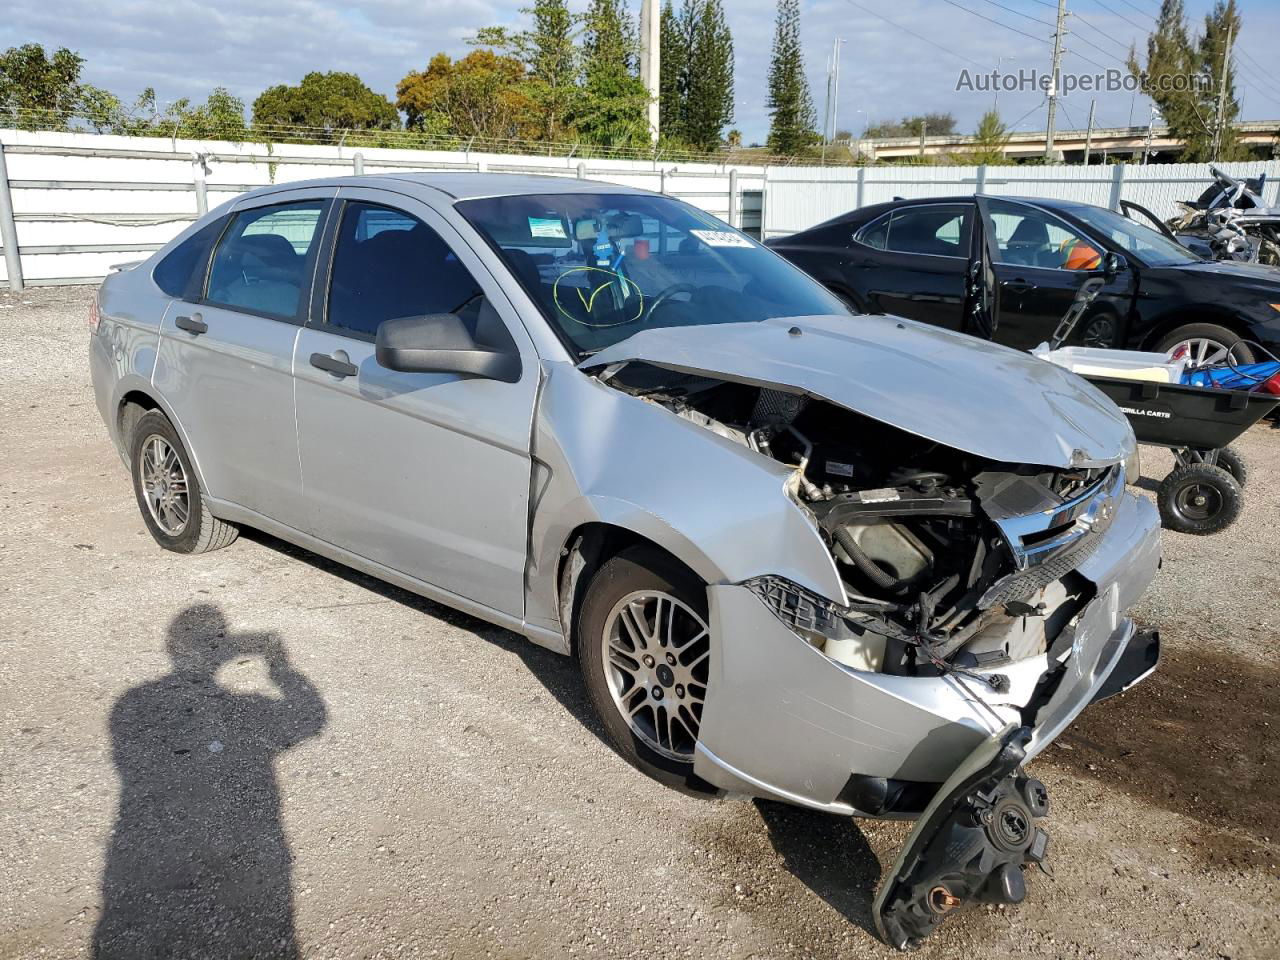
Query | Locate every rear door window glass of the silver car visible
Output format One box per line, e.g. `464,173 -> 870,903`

206,200 -> 328,320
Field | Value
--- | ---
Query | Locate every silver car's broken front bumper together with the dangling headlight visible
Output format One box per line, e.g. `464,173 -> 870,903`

694,494 -> 1160,950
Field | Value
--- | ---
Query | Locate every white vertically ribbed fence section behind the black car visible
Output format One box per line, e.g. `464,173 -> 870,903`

763,160 -> 1280,237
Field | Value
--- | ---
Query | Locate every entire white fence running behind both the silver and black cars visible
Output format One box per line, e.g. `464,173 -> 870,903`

0,131 -> 1280,287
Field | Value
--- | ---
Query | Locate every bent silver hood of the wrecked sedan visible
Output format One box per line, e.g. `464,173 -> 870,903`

579,316 -> 1133,467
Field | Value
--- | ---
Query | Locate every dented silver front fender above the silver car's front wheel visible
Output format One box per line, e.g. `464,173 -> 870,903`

525,362 -> 846,642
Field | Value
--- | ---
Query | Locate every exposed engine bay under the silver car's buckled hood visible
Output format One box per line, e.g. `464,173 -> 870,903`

600,362 -> 1124,690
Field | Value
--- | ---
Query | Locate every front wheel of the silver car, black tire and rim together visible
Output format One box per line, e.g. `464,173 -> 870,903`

577,548 -> 710,790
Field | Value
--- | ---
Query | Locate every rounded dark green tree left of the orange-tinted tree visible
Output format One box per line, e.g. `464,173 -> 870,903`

253,70 -> 401,140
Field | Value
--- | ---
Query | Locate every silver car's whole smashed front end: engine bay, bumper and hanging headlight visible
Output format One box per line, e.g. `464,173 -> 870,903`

588,362 -> 1158,948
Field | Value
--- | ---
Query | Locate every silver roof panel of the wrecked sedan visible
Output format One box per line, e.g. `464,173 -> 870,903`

232,170 -> 652,207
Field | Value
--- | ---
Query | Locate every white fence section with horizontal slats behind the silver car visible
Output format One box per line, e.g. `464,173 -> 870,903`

0,129 -> 764,285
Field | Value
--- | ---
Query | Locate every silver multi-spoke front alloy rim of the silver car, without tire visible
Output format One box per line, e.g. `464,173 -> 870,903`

600,590 -> 710,762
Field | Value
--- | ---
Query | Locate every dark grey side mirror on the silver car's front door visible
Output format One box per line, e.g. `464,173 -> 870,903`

375,314 -> 520,383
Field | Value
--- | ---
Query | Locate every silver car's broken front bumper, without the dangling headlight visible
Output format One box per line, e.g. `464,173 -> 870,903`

694,494 -> 1160,818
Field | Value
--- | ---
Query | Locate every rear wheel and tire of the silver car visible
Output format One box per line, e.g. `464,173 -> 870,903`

129,410 -> 239,553
